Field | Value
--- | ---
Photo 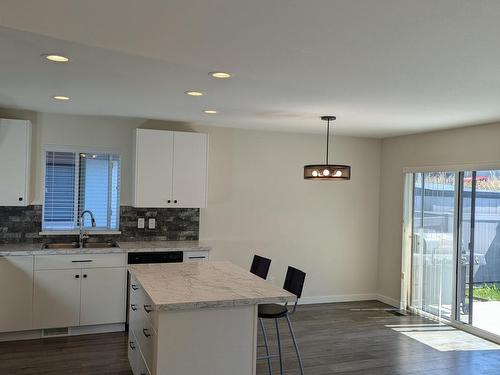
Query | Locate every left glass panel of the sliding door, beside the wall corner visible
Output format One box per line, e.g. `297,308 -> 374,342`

411,172 -> 456,319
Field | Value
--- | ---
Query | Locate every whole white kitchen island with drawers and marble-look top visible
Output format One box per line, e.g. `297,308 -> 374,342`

129,262 -> 295,375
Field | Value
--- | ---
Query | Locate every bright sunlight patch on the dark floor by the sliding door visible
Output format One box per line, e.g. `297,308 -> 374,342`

386,323 -> 500,352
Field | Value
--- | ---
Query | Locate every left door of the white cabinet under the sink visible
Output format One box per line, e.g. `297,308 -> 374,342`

33,269 -> 81,328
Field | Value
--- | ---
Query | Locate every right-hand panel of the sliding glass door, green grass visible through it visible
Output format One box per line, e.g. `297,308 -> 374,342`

456,170 -> 500,335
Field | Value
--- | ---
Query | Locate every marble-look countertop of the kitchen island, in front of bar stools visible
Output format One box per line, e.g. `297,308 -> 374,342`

129,262 -> 296,311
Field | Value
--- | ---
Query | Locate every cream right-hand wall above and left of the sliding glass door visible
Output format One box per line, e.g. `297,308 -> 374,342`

378,124 -> 500,301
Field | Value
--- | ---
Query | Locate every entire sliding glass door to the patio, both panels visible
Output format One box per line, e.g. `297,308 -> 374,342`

409,170 -> 500,336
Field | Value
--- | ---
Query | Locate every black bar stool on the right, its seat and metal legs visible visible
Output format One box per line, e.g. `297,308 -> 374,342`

257,267 -> 306,375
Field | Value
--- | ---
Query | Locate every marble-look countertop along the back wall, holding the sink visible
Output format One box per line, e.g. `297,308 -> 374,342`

0,241 -> 210,256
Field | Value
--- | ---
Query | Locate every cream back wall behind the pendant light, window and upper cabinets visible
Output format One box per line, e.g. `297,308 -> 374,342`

0,110 -> 381,301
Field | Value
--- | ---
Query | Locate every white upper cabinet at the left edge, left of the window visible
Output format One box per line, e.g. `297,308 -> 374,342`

0,119 -> 31,206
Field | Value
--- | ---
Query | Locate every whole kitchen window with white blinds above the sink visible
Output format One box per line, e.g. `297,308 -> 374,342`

42,150 -> 120,231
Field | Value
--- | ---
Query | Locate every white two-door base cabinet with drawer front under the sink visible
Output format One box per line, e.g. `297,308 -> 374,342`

33,254 -> 126,329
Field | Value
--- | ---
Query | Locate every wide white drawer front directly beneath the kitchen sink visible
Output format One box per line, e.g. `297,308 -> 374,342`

35,254 -> 126,270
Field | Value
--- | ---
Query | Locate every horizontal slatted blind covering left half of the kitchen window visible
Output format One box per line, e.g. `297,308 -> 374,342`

42,151 -> 77,230
